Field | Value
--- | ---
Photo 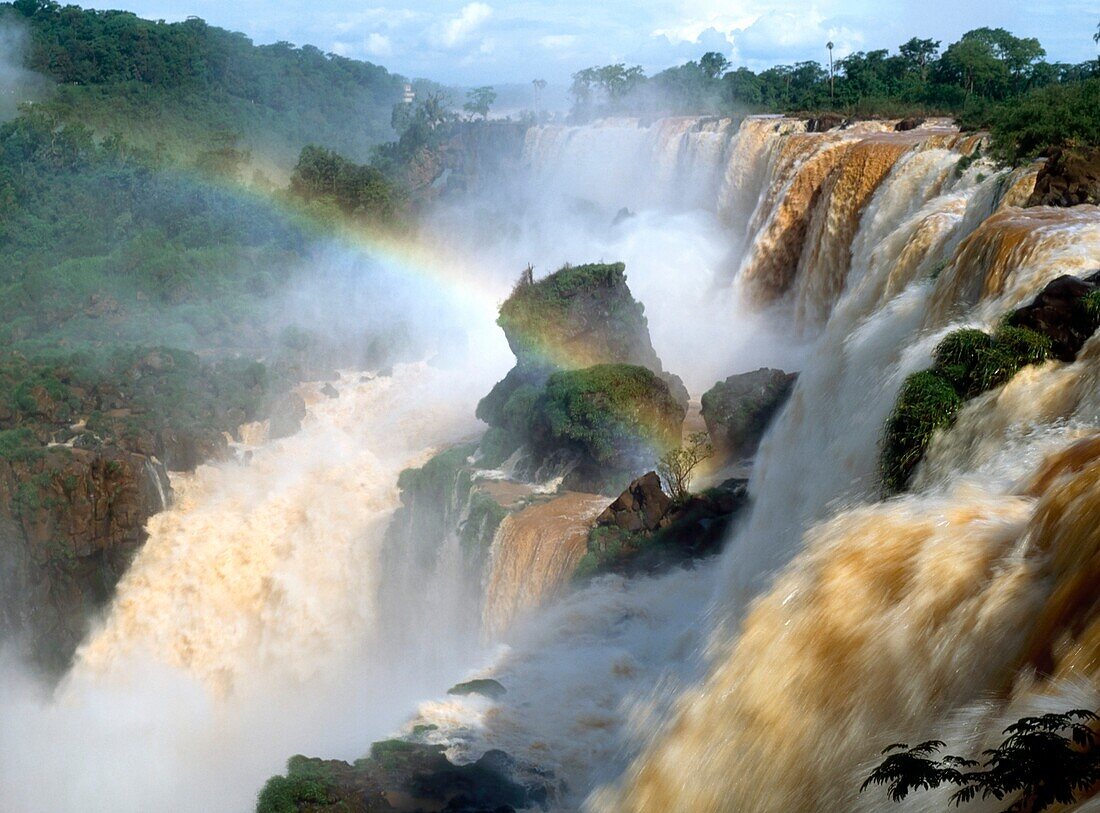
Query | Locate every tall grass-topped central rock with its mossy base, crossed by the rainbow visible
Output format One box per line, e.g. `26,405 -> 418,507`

477,263 -> 688,493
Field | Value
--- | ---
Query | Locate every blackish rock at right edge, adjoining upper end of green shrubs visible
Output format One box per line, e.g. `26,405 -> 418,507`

1009,272 -> 1100,362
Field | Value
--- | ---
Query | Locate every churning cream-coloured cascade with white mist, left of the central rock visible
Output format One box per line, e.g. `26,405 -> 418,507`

0,364 -> 486,813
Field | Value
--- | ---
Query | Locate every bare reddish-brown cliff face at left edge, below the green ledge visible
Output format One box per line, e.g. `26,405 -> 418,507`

0,449 -> 171,671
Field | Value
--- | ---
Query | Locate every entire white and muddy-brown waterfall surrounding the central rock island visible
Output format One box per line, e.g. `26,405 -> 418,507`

0,109 -> 1100,813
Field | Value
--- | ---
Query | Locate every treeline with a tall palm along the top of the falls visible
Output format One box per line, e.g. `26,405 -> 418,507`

571,28 -> 1100,161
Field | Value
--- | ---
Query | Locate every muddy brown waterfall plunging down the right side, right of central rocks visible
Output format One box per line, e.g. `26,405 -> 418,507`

589,121 -> 1100,813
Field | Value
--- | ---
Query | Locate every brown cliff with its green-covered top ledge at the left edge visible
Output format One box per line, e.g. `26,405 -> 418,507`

0,348 -> 288,674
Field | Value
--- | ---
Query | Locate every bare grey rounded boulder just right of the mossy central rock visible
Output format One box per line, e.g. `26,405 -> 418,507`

703,367 -> 799,459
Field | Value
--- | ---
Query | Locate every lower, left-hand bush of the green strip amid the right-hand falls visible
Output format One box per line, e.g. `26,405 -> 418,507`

882,369 -> 959,493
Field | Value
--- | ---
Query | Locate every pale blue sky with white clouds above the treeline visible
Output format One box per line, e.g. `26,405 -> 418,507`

86,0 -> 1100,85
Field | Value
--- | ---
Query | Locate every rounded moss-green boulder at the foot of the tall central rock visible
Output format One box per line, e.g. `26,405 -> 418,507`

536,364 -> 684,468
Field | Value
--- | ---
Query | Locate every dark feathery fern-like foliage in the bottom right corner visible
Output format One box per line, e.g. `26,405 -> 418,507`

860,708 -> 1100,813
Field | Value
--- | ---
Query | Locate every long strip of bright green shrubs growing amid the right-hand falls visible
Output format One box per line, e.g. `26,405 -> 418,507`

882,325 -> 1052,493
